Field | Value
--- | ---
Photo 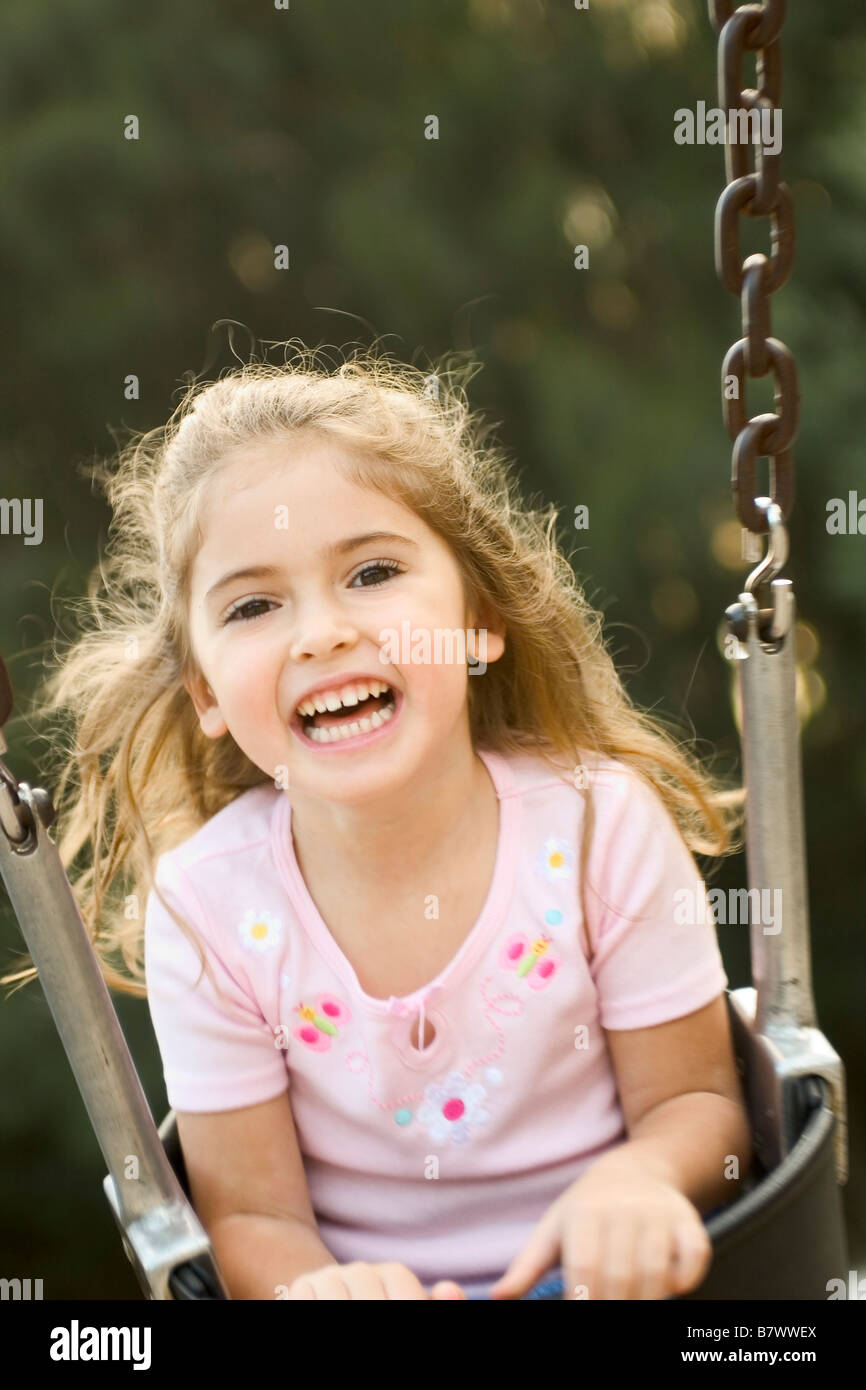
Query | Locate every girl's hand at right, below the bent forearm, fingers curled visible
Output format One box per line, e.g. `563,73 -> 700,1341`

491,1152 -> 713,1300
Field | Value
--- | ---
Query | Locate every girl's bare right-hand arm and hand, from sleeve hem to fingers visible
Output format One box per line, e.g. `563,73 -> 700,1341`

491,994 -> 752,1298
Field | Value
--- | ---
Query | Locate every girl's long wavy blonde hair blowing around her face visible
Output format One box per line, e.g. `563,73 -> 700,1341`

0,341 -> 745,997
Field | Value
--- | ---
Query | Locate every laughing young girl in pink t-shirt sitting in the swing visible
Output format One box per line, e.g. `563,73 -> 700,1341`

3,350 -> 751,1300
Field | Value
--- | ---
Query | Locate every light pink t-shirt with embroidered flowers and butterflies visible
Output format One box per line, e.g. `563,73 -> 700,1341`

145,752 -> 728,1294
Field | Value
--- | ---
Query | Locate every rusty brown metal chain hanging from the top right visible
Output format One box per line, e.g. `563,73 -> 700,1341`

709,0 -> 799,547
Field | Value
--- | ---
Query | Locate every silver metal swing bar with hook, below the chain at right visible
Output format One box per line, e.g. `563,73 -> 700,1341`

726,525 -> 848,1184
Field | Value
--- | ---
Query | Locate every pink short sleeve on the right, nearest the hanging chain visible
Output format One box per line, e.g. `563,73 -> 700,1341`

585,765 -> 728,1030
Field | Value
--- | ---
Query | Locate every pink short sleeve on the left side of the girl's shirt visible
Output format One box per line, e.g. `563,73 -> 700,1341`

145,856 -> 289,1112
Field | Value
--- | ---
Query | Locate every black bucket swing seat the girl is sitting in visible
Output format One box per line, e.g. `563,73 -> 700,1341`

147,990 -> 848,1301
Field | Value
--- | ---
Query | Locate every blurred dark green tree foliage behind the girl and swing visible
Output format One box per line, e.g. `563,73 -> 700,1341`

0,0 -> 866,1298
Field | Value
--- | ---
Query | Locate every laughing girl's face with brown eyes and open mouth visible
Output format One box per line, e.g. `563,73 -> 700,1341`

186,438 -> 505,802
